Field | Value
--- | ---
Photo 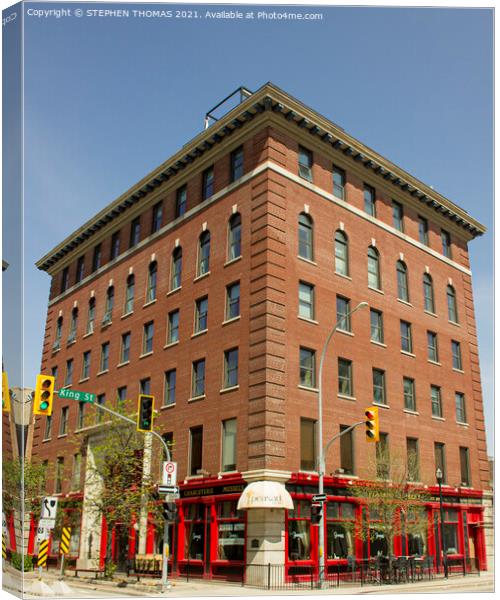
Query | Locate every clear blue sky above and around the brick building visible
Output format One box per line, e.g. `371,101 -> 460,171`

4,2 -> 494,454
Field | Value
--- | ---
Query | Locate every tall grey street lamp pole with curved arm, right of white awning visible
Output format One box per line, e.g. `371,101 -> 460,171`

317,302 -> 368,588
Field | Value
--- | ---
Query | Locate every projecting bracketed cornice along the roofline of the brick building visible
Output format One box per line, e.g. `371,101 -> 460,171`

36,83 -> 486,271
